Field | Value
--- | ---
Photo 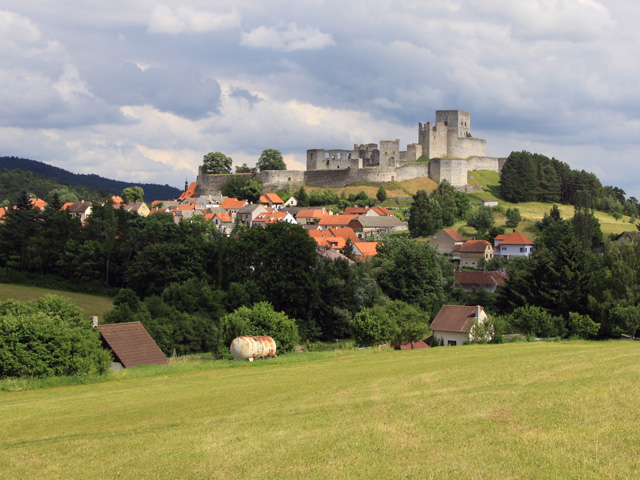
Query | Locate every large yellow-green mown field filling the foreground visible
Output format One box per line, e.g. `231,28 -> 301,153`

0,341 -> 640,479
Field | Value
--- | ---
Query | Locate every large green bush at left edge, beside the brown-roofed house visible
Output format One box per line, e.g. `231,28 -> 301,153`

0,295 -> 111,378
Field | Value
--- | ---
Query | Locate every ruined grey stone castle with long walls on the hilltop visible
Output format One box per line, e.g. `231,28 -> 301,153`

196,110 -> 505,195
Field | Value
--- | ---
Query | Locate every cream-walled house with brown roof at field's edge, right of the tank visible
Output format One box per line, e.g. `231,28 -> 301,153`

431,305 -> 487,346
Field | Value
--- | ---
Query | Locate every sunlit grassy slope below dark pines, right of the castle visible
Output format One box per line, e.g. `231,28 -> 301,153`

464,170 -> 635,237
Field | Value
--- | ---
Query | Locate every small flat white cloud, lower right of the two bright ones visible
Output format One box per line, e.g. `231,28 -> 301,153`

240,22 -> 335,52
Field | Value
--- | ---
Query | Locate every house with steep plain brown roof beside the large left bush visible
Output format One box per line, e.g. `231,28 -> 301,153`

96,322 -> 169,369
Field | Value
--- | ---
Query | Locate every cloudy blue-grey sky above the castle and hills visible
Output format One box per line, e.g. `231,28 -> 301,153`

0,0 -> 640,198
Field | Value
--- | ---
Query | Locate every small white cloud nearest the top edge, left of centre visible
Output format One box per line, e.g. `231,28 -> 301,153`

148,5 -> 240,35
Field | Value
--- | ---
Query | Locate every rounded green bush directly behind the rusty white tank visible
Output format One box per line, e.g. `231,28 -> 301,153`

219,302 -> 299,357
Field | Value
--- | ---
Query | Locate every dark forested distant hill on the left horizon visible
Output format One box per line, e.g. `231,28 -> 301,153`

0,157 -> 182,202
